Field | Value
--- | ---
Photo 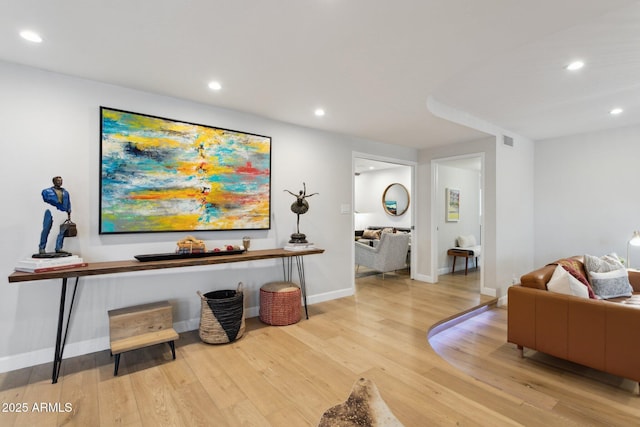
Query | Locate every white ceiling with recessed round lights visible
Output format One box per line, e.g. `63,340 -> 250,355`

0,0 -> 640,148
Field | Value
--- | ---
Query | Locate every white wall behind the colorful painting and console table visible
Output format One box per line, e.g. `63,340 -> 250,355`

0,62 -> 417,371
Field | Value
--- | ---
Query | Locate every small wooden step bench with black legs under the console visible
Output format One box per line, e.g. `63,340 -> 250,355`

109,301 -> 179,376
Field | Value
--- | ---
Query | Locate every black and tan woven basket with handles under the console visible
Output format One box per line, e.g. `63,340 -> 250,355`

198,283 -> 245,344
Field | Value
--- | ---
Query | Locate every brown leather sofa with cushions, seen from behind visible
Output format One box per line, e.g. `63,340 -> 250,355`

507,257 -> 640,392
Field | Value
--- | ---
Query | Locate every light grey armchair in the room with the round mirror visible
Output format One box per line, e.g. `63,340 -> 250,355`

355,233 -> 411,279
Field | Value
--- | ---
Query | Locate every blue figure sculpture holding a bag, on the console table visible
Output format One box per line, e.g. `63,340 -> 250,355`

33,176 -> 77,258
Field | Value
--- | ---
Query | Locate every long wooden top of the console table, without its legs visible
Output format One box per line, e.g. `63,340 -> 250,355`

9,249 -> 324,283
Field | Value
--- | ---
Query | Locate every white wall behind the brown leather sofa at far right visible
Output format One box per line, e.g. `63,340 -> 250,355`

534,126 -> 640,268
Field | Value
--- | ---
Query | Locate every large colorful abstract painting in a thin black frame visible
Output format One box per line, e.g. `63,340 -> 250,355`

100,107 -> 271,234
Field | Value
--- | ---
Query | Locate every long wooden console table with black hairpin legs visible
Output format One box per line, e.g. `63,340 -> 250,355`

9,249 -> 324,384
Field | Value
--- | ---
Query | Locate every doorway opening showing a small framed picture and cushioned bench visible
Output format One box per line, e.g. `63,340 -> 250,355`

431,153 -> 484,293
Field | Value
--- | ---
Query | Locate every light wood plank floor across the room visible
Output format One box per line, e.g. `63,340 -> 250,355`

0,272 -> 640,427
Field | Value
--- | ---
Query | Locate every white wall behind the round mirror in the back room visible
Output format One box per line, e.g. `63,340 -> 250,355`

354,166 -> 414,230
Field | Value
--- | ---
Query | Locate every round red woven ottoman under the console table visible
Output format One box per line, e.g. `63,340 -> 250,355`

260,282 -> 301,326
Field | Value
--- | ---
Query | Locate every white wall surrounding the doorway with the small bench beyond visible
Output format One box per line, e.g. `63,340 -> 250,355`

416,135 -> 534,297
